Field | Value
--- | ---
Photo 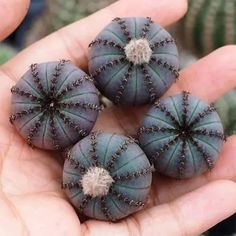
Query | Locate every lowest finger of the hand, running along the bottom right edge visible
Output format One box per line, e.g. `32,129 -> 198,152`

82,180 -> 236,236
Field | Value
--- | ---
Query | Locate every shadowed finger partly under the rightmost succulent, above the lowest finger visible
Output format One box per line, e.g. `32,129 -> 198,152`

152,135 -> 236,204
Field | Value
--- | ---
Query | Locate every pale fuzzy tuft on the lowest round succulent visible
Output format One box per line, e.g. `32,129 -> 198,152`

81,167 -> 114,197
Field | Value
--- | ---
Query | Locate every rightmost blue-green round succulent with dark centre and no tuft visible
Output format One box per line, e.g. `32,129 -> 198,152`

138,92 -> 224,178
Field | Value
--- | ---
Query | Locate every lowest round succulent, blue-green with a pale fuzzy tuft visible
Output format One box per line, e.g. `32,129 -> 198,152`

62,132 -> 152,221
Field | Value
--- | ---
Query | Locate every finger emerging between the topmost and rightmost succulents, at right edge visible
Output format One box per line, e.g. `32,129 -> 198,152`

165,45 -> 236,102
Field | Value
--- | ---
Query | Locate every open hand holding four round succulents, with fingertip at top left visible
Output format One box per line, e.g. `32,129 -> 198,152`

0,0 -> 236,236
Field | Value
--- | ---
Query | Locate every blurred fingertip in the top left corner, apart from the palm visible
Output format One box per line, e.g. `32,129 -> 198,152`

0,0 -> 29,40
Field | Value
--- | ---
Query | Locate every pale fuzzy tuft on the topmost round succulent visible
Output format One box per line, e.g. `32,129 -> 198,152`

125,38 -> 152,65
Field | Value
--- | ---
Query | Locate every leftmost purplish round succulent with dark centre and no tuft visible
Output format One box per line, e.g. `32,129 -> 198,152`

10,60 -> 99,150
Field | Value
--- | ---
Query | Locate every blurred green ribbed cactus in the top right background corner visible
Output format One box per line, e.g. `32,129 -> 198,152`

183,0 -> 236,55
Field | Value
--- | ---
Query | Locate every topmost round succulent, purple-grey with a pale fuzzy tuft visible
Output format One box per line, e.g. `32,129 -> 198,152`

89,17 -> 179,105
